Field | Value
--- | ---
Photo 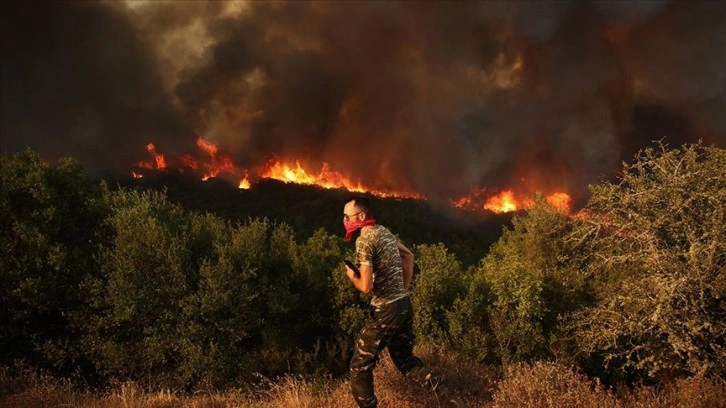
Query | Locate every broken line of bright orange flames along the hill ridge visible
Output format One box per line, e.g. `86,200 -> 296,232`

131,135 -> 572,213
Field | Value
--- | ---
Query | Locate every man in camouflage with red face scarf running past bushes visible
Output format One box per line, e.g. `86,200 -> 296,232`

343,197 -> 466,408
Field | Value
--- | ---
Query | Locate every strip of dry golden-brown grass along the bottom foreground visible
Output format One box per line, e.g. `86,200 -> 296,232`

0,347 -> 726,408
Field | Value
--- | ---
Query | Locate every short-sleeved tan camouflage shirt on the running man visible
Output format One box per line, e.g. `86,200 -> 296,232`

355,225 -> 408,306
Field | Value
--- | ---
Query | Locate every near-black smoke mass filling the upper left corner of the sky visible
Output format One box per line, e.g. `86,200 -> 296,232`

0,2 -> 191,172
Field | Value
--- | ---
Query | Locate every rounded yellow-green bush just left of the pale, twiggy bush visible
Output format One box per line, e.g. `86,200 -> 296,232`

470,197 -> 590,362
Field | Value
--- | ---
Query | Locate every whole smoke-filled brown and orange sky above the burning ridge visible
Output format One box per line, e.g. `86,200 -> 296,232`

0,1 -> 726,204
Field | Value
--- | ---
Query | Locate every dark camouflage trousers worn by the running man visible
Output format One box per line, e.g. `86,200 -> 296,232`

350,297 -> 441,407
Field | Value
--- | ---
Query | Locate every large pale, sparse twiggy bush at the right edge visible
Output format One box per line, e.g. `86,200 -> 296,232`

569,141 -> 726,380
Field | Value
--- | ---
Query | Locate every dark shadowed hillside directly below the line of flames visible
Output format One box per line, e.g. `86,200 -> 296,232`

105,172 -> 512,265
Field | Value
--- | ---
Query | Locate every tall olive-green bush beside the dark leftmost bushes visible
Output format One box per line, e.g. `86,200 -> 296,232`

78,190 -> 195,382
